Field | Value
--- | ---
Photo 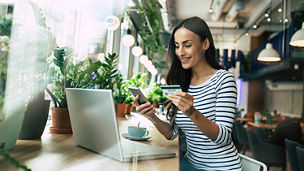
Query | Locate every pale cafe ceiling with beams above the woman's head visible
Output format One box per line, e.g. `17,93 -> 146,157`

164,0 -> 304,41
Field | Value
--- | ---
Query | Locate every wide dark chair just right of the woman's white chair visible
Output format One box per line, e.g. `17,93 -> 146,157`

247,129 -> 286,170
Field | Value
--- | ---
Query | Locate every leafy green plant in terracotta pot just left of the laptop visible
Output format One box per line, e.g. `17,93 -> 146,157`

46,47 -> 101,134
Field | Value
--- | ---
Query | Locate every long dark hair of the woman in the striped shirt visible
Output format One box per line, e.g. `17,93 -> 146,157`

166,17 -> 222,92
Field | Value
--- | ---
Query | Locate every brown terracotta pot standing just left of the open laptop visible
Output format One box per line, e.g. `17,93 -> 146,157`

50,107 -> 72,134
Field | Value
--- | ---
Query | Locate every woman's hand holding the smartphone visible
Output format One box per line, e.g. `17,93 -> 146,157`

134,95 -> 155,120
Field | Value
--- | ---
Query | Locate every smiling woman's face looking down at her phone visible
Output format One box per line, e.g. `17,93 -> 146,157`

174,27 -> 207,69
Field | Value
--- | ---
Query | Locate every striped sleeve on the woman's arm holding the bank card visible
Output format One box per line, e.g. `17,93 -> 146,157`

214,72 -> 237,145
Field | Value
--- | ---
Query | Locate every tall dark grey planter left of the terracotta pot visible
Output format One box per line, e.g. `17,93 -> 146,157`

18,91 -> 50,140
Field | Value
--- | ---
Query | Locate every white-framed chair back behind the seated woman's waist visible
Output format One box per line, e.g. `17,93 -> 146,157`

239,154 -> 267,171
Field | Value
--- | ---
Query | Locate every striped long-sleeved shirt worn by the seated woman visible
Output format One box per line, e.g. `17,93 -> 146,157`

171,70 -> 242,170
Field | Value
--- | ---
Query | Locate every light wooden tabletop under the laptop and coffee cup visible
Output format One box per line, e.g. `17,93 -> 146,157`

0,114 -> 179,171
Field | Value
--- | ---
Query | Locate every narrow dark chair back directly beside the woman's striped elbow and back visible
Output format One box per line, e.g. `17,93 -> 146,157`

233,121 -> 249,154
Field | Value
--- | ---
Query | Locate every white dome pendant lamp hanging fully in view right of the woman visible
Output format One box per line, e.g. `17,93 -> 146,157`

258,43 -> 281,62
